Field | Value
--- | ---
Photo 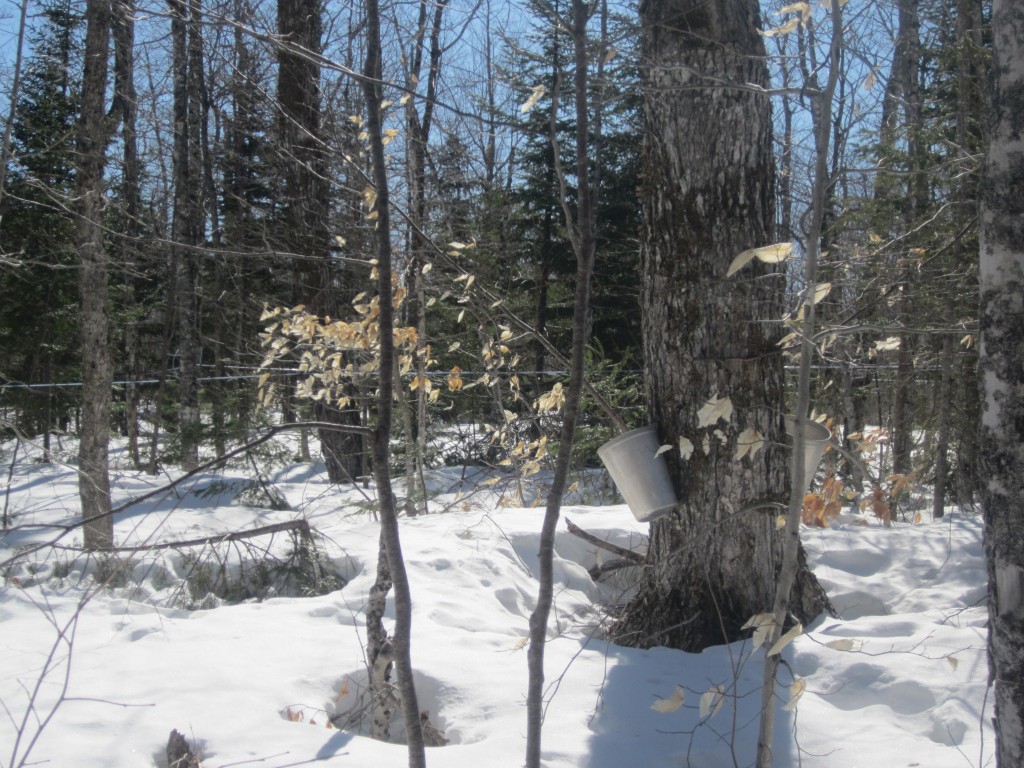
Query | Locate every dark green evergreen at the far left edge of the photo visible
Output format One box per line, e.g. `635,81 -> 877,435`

0,0 -> 81,447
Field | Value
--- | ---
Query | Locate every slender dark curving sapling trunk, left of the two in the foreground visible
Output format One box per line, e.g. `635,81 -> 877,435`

362,0 -> 426,768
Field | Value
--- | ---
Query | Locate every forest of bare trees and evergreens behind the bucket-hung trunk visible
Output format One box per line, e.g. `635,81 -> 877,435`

0,0 -> 1007,765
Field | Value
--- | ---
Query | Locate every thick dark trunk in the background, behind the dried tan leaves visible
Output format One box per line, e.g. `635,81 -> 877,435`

278,0 -> 362,482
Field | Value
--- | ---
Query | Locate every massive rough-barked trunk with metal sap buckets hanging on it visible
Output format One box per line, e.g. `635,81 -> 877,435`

615,0 -> 826,650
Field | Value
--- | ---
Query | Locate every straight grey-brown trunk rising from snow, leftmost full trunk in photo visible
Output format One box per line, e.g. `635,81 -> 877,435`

77,0 -> 114,549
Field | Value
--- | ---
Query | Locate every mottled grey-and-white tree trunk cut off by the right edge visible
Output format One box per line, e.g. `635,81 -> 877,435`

981,0 -> 1024,768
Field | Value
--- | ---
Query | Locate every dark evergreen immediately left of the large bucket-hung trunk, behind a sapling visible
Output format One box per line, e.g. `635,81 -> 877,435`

501,3 -> 641,390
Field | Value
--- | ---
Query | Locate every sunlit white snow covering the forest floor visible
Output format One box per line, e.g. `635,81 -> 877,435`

0,443 -> 993,768
